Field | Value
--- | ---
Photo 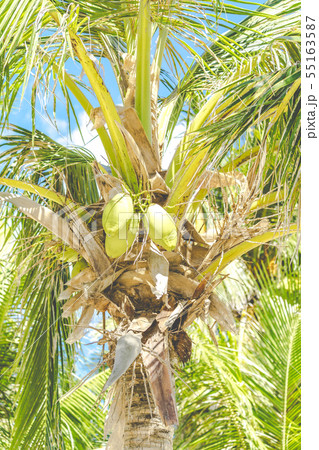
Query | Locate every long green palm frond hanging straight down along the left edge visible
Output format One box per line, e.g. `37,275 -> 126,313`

0,217 -> 73,448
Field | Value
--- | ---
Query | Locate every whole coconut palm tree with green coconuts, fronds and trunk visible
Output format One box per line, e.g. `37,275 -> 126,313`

0,0 -> 300,448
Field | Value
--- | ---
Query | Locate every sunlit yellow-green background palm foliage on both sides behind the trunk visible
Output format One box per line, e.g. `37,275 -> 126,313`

1,246 -> 301,449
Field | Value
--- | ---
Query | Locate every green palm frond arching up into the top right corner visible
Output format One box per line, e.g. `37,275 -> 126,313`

162,0 -> 300,142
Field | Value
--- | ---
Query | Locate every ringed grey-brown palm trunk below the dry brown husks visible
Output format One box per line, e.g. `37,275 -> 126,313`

107,358 -> 174,450
